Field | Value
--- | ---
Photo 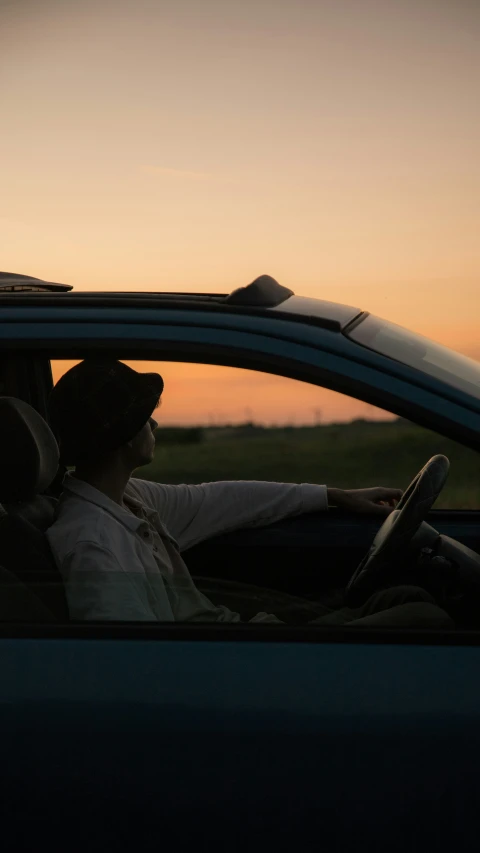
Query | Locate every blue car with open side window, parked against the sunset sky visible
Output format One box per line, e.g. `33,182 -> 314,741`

0,273 -> 480,853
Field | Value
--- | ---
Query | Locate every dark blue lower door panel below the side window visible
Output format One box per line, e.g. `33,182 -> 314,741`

0,629 -> 480,853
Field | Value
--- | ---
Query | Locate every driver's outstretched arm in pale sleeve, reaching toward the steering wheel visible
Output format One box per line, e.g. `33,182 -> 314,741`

130,480 -> 328,550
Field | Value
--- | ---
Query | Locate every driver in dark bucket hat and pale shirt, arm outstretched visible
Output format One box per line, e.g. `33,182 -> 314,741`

47,359 -> 449,626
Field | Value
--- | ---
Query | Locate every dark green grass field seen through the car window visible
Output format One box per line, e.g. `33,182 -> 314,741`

138,420 -> 480,509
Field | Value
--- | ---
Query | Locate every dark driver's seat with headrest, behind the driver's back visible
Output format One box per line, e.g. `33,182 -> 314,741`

0,397 -> 68,622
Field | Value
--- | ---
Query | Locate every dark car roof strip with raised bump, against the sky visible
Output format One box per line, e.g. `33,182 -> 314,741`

0,272 -> 366,332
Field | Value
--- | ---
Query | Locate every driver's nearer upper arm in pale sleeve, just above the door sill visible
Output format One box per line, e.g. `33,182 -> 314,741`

60,541 -> 158,622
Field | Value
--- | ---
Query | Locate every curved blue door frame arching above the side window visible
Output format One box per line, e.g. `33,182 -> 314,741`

0,305 -> 480,450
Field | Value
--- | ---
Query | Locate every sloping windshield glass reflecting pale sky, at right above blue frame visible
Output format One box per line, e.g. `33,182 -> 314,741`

347,316 -> 480,400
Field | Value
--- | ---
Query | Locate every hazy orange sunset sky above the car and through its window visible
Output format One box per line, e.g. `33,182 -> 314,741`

0,0 -> 480,422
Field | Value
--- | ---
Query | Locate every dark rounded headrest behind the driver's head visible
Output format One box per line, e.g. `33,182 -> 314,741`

0,397 -> 59,503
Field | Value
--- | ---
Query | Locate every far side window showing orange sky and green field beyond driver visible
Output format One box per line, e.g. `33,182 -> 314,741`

52,360 -> 480,509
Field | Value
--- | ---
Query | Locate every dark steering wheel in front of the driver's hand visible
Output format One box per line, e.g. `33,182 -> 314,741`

345,455 -> 450,607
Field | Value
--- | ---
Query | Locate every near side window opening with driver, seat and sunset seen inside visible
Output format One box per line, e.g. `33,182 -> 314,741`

0,354 -> 480,632
